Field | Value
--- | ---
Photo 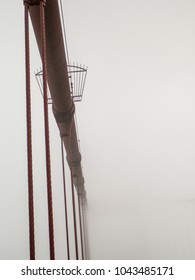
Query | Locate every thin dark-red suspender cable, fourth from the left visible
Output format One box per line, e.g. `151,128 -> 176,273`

69,138 -> 79,260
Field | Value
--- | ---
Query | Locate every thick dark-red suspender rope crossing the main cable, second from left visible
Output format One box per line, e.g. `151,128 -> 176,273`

40,0 -> 55,260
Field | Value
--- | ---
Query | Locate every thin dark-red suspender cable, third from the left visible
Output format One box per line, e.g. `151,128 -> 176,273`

61,137 -> 70,260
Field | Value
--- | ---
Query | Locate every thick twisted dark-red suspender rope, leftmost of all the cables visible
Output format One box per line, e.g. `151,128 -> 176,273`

24,1 -> 35,260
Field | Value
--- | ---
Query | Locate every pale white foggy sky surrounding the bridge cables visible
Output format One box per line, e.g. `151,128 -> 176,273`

0,0 -> 195,259
